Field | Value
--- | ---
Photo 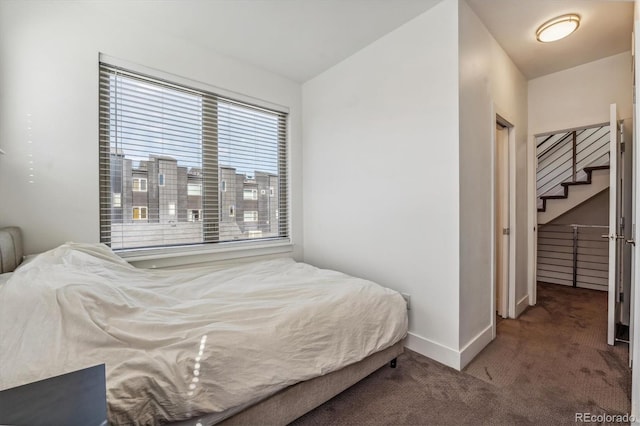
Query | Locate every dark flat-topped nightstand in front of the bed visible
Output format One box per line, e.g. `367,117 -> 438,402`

0,364 -> 107,426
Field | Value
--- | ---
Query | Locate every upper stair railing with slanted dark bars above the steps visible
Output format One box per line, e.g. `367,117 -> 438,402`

536,124 -> 609,197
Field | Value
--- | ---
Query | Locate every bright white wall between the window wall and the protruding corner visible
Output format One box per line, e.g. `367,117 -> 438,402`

303,0 -> 459,365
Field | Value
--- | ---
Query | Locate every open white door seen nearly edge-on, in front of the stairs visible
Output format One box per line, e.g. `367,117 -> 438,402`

607,104 -> 624,345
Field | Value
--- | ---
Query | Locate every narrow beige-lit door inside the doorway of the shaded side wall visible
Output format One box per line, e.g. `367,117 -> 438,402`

495,123 -> 509,318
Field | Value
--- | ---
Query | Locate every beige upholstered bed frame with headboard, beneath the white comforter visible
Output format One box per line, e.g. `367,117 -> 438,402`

0,227 -> 404,426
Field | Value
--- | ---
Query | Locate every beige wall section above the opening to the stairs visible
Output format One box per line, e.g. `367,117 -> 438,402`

529,52 -> 633,137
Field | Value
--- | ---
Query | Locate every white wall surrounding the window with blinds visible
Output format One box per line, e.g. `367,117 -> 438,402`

0,2 -> 302,257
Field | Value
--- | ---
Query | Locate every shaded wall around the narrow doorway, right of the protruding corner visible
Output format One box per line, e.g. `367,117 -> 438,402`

459,1 -> 528,365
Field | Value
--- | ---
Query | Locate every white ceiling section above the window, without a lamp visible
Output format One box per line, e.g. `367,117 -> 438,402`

108,0 -> 441,82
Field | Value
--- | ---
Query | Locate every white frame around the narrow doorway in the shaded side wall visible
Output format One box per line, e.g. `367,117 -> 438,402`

490,111 -> 517,338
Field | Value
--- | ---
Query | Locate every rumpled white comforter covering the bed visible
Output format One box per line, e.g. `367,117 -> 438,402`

0,244 -> 407,424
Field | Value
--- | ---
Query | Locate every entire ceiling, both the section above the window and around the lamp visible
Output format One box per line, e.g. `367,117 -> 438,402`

108,0 -> 633,82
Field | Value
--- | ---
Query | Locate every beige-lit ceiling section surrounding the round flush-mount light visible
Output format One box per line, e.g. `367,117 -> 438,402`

467,0 -> 633,79
